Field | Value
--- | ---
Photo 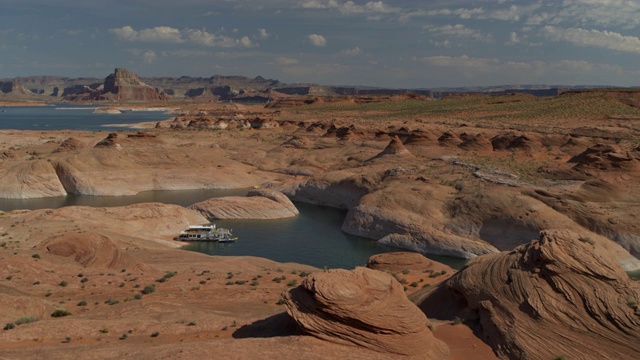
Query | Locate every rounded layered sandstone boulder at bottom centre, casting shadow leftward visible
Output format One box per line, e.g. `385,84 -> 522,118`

283,268 -> 449,359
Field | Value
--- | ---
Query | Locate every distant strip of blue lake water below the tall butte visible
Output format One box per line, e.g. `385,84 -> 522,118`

0,103 -> 172,131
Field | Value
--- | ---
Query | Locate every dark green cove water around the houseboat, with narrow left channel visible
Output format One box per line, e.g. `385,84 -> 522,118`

0,189 -> 465,269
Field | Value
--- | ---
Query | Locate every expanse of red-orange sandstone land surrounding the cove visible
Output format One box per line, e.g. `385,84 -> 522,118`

0,86 -> 640,359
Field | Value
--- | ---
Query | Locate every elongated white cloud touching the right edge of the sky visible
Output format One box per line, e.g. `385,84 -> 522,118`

542,26 -> 640,54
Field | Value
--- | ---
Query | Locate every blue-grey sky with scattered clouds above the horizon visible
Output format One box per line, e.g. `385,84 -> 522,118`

0,0 -> 640,88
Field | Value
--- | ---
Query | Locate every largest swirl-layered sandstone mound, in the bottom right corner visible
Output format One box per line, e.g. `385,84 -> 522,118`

412,230 -> 640,359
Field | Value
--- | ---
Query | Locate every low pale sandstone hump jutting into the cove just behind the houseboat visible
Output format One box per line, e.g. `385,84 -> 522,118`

189,188 -> 298,219
